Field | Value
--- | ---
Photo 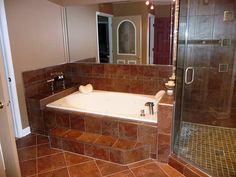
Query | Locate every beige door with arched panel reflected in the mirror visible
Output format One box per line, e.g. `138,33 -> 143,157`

112,16 -> 142,64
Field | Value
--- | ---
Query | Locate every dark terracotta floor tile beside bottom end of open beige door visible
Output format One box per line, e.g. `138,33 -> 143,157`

20,160 -> 36,177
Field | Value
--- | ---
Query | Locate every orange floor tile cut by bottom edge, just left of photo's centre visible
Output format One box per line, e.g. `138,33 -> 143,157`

68,161 -> 101,177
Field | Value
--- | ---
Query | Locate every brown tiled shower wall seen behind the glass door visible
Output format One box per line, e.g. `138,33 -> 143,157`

178,0 -> 236,127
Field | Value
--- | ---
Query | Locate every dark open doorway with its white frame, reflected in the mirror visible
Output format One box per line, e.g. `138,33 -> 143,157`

96,12 -> 113,63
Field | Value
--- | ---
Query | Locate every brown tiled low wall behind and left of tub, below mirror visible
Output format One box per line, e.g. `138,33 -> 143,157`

23,63 -> 172,134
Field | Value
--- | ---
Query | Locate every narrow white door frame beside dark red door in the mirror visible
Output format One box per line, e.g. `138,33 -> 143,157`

147,13 -> 155,64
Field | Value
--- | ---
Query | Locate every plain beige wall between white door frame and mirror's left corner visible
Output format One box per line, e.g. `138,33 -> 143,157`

5,0 -> 65,128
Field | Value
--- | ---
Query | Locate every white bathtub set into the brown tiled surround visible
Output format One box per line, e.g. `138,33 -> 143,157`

47,90 -> 164,123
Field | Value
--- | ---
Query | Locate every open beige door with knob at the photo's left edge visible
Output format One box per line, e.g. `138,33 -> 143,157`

0,32 -> 20,177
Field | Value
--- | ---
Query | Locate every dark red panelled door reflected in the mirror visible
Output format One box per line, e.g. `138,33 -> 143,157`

154,17 -> 171,65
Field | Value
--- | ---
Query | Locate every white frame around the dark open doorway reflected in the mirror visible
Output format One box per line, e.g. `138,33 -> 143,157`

96,11 -> 113,63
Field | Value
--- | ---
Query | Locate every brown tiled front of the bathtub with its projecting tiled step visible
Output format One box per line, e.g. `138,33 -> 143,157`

44,108 -> 157,164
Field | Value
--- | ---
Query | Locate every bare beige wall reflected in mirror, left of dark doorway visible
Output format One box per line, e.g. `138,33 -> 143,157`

66,5 -> 98,62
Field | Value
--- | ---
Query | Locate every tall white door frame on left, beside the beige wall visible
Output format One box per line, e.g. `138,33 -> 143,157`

0,0 -> 27,138
